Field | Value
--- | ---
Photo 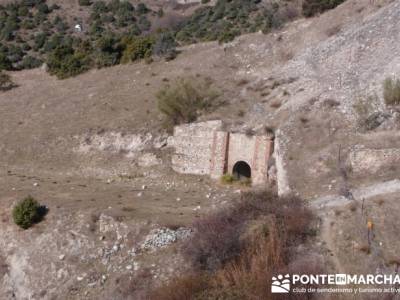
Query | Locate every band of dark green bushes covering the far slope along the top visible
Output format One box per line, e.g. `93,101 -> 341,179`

0,0 -> 344,78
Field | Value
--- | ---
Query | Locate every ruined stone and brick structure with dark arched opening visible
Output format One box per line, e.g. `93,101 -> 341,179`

168,121 -> 273,184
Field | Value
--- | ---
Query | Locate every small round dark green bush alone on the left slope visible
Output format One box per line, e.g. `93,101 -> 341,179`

12,196 -> 45,229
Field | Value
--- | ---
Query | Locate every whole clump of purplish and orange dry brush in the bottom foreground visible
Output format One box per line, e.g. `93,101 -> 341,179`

150,191 -> 322,300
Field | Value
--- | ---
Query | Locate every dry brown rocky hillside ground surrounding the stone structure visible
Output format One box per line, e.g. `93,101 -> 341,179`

0,0 -> 400,299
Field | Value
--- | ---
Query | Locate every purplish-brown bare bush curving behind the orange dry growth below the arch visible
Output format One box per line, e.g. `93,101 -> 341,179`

183,191 -> 311,270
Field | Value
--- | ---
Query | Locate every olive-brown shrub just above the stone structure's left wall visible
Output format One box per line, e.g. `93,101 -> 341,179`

156,78 -> 219,127
